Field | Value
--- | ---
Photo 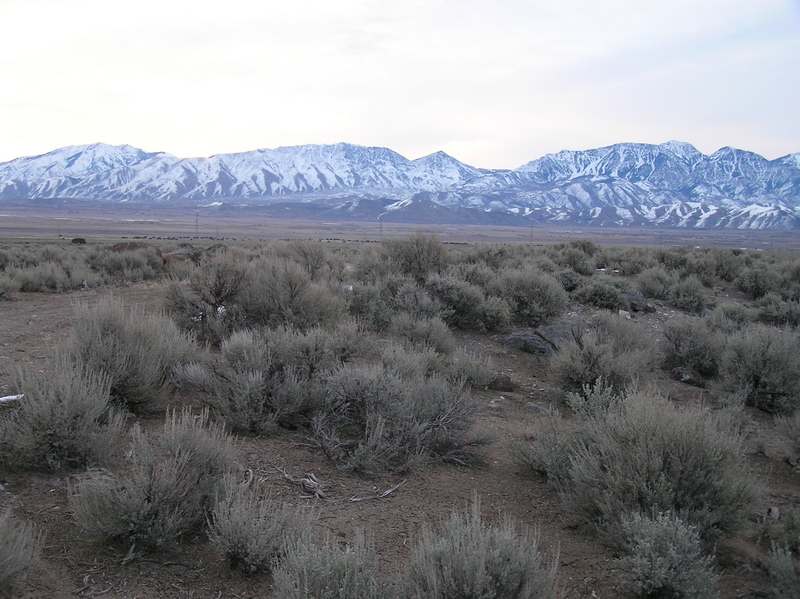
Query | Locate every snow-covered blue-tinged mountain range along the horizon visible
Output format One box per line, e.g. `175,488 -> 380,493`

0,141 -> 800,229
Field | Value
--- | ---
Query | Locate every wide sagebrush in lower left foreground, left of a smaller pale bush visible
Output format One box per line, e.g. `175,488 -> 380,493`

69,409 -> 235,551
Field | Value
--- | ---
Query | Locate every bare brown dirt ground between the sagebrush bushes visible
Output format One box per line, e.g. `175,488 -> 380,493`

0,283 -> 800,599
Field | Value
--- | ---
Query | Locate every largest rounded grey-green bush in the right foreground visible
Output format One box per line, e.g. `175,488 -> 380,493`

563,393 -> 756,546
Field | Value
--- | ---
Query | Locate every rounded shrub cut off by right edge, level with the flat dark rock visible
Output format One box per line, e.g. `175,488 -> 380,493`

720,326 -> 800,412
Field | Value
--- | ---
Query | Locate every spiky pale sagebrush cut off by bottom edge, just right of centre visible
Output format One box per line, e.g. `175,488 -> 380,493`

403,499 -> 557,599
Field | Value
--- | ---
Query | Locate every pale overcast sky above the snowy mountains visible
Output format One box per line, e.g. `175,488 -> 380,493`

0,0 -> 800,168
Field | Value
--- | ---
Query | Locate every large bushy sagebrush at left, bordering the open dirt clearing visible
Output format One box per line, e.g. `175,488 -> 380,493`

66,297 -> 202,414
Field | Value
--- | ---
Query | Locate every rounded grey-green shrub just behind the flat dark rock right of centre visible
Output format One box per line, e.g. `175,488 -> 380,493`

493,267 -> 567,327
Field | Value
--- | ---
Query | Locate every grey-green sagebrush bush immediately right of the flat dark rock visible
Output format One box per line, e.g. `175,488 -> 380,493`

551,314 -> 655,393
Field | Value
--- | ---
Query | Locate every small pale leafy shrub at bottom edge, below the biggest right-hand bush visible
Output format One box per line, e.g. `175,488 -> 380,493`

617,513 -> 719,599
